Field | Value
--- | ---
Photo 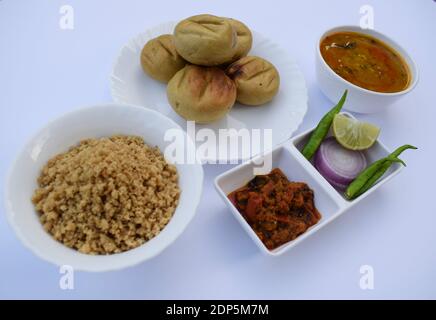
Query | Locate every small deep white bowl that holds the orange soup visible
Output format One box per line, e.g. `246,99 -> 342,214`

316,26 -> 418,113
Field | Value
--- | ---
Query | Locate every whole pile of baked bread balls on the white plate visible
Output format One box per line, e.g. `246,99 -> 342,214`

141,14 -> 280,123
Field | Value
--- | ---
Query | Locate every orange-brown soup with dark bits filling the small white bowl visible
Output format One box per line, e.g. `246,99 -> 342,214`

320,32 -> 410,93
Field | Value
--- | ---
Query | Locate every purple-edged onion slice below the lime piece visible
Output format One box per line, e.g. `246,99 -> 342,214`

315,137 -> 367,190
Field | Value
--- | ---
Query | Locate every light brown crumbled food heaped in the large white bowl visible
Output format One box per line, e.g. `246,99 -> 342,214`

32,136 -> 180,254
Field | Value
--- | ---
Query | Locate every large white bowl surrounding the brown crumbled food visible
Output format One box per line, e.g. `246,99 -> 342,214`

5,104 -> 203,271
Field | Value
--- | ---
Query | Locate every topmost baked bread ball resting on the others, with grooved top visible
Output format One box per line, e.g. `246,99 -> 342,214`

174,14 -> 237,66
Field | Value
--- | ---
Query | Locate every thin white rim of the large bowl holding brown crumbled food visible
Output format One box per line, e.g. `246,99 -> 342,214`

4,102 -> 204,272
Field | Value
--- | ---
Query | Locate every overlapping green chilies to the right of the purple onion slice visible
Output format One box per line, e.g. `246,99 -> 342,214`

345,144 -> 417,200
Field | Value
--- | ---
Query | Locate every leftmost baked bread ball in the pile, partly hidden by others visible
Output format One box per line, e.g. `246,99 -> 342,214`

141,34 -> 186,83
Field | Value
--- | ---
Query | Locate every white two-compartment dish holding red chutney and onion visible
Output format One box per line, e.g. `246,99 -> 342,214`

215,113 -> 402,256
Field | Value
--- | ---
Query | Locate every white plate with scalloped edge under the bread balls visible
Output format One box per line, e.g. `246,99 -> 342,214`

110,22 -> 307,160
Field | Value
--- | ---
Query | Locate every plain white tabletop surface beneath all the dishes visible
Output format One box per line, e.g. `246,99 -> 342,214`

0,0 -> 436,299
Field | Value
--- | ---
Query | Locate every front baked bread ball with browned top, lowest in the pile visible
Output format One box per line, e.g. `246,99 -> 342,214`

167,65 -> 236,123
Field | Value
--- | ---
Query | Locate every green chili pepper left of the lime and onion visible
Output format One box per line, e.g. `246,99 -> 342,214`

301,90 -> 348,160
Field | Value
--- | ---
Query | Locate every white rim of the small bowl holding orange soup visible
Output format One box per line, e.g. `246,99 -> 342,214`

316,25 -> 419,96
